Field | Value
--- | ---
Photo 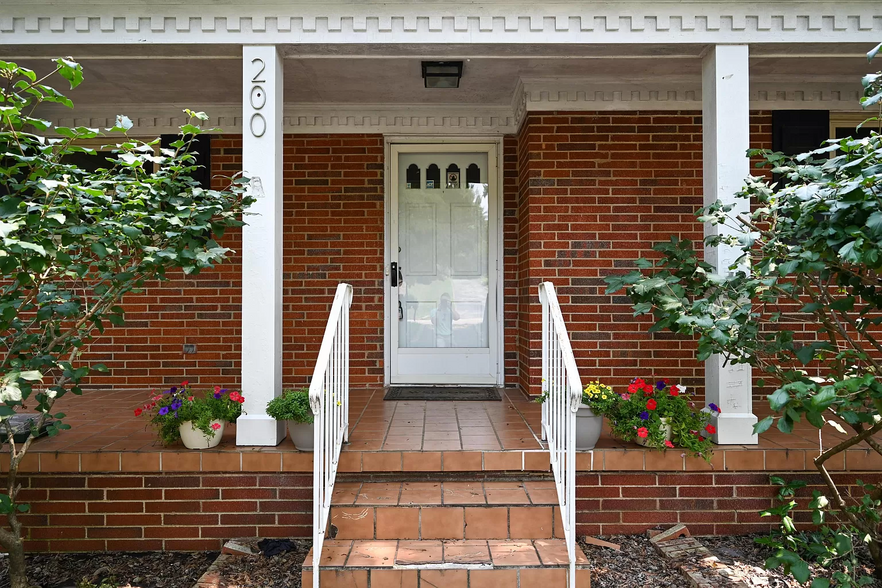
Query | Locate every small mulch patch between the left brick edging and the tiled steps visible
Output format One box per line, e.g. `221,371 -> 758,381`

212,539 -> 312,588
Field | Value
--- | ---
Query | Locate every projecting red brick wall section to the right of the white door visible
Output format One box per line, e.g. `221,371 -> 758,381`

518,111 -> 771,395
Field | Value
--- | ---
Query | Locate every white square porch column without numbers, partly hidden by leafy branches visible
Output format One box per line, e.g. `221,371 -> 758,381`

701,45 -> 757,445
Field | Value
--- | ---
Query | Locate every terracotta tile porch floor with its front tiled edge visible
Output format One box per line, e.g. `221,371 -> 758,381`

13,388 -> 882,472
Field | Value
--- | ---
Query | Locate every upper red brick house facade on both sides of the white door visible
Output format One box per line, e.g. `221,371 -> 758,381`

81,116 -> 771,393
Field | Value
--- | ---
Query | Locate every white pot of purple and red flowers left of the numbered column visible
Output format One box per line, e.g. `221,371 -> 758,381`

135,381 -> 245,449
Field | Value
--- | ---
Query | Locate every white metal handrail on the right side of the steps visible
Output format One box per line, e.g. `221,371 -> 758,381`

539,282 -> 582,588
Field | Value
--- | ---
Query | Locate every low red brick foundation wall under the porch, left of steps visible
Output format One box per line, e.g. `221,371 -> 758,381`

21,472 -> 312,551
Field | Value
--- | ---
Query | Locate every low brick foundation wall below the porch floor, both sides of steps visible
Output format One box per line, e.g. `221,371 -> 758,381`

21,471 -> 882,551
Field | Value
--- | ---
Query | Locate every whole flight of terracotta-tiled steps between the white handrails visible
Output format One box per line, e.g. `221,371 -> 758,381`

303,477 -> 590,588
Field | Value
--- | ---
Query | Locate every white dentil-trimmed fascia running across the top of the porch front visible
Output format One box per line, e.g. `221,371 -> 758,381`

0,0 -> 882,45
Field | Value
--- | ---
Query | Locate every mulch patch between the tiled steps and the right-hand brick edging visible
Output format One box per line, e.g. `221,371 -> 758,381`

579,535 -> 689,588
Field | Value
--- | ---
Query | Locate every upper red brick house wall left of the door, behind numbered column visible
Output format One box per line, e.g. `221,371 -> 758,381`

86,135 -> 383,388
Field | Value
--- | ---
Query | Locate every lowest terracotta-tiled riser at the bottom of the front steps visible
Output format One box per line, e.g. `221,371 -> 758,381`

301,568 -> 591,588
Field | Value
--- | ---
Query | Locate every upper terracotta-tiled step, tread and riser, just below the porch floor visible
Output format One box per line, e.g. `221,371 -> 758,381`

330,481 -> 563,540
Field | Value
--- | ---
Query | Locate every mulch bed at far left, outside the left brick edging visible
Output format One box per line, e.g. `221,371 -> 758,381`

0,551 -> 217,588
